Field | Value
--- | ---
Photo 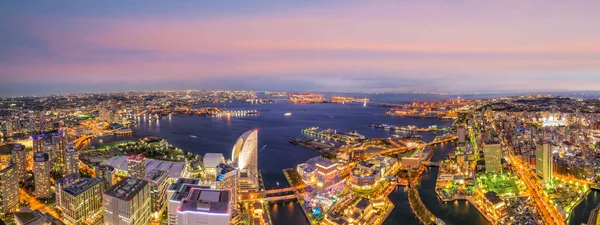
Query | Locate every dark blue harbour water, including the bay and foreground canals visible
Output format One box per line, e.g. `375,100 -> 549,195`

86,101 -> 600,225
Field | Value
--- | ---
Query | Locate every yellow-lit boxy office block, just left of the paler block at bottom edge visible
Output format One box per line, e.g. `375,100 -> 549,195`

57,178 -> 104,224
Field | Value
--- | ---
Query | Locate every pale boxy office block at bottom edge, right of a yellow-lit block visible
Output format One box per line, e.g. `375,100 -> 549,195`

103,177 -> 152,225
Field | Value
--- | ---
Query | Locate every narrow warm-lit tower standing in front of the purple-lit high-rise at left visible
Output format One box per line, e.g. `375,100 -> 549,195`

33,152 -> 52,198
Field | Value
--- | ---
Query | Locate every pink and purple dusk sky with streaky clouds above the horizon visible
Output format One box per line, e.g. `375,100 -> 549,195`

0,0 -> 600,96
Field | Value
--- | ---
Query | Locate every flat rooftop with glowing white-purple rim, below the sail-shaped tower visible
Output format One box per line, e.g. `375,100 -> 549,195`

177,188 -> 231,214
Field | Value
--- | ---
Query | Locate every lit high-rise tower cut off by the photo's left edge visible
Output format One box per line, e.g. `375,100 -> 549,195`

0,162 -> 19,215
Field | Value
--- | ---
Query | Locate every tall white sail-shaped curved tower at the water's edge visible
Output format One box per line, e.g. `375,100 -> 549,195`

231,129 -> 258,191
